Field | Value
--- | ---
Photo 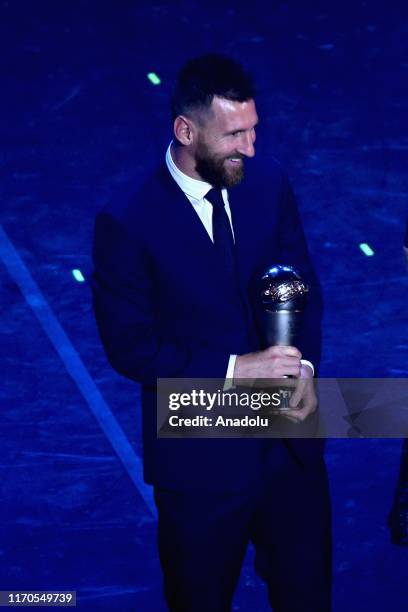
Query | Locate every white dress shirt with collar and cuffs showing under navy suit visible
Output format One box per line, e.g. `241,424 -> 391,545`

166,142 -> 314,379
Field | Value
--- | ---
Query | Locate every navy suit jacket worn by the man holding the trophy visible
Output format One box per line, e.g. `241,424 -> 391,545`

92,161 -> 323,491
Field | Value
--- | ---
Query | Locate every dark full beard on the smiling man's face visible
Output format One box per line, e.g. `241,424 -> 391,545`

195,141 -> 244,188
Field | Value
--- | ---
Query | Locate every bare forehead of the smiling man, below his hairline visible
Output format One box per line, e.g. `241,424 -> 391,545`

207,96 -> 258,131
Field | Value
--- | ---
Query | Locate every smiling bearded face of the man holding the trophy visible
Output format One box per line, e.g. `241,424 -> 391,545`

194,96 -> 258,187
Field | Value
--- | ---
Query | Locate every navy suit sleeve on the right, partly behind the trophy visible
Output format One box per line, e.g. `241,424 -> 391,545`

278,175 -> 323,375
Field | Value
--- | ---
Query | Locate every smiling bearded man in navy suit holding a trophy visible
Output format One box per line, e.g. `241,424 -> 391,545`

93,55 -> 331,612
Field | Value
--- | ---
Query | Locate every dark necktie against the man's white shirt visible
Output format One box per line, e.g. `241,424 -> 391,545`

205,189 -> 235,276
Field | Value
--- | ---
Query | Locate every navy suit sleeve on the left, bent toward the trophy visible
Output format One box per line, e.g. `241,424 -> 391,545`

91,212 -> 229,386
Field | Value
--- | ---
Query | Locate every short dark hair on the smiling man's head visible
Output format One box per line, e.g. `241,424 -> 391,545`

171,53 -> 255,120
